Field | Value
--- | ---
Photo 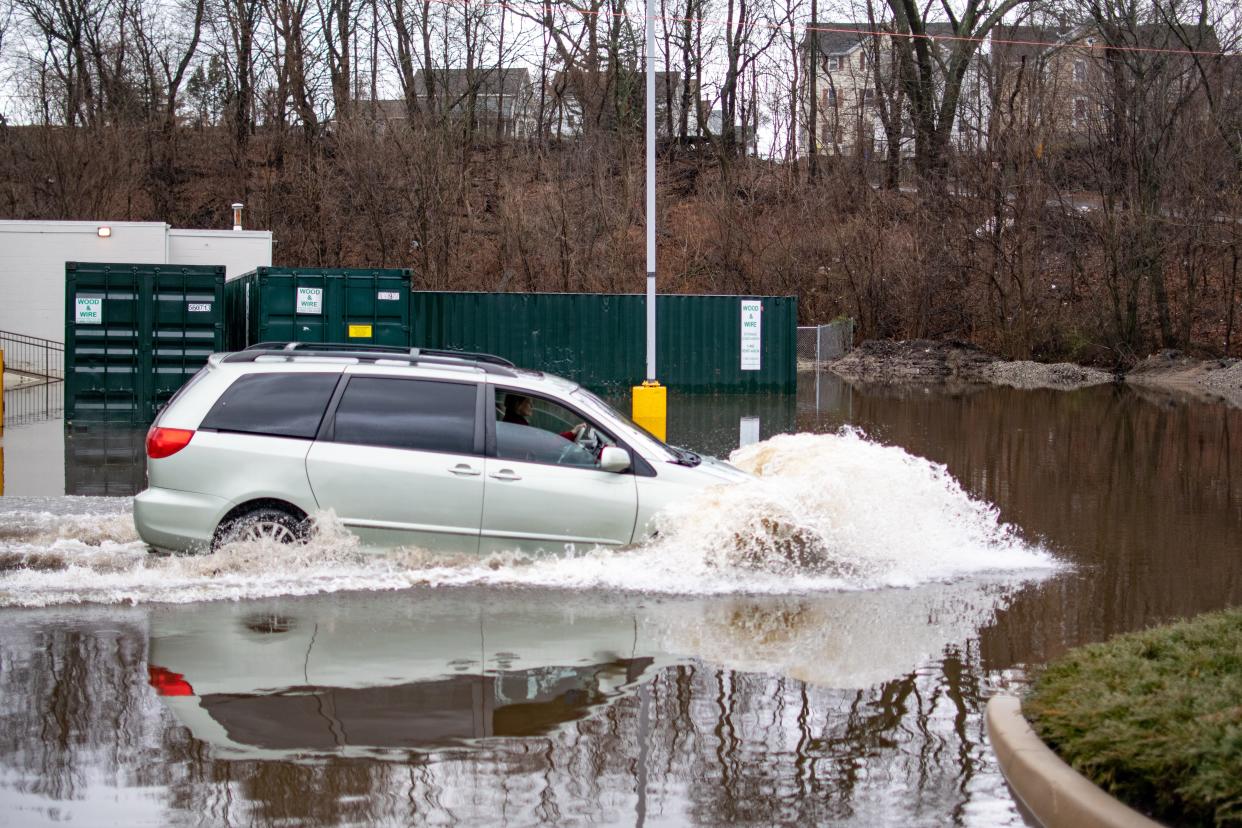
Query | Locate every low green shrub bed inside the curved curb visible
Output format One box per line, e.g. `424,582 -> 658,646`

1023,610 -> 1242,826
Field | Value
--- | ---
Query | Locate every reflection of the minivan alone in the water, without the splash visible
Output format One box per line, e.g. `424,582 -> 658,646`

149,593 -> 668,758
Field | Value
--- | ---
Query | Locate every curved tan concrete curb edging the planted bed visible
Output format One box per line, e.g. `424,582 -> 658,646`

986,695 -> 1160,828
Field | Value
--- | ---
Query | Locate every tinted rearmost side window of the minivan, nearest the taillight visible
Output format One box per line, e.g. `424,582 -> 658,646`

199,374 -> 340,439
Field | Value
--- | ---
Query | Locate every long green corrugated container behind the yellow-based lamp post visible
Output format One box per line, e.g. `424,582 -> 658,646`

410,290 -> 797,394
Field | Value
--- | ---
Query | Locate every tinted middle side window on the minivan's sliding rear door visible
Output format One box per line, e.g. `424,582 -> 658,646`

333,376 -> 478,454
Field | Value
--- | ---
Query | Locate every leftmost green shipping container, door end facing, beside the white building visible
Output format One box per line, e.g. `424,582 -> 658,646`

65,262 -> 225,423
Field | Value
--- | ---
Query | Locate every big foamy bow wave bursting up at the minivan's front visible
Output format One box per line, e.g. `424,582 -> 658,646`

660,428 -> 1052,588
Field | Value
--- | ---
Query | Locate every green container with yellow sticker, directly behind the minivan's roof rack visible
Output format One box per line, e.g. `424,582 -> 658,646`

225,267 -> 410,350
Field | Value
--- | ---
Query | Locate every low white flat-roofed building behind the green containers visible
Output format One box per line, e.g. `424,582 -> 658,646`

0,221 -> 272,341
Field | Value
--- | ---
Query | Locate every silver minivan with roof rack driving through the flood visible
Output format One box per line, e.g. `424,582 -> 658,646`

134,343 -> 749,552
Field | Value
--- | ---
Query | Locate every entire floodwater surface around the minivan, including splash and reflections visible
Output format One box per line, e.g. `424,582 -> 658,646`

0,375 -> 1242,826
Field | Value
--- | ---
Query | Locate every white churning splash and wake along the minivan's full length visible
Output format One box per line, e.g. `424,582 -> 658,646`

0,430 -> 1057,606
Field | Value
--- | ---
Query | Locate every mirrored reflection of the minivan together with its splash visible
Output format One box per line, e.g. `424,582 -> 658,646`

148,583 -> 1016,758
